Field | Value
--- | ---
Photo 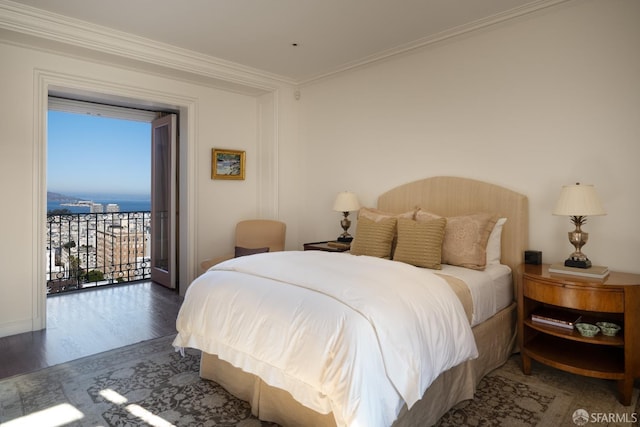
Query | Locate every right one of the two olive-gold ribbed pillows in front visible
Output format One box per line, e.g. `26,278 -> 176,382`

393,218 -> 447,270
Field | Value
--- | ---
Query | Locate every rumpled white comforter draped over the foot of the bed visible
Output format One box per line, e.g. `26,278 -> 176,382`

174,251 -> 477,427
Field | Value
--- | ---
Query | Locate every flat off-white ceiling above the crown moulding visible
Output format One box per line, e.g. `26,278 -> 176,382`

8,0 -> 559,82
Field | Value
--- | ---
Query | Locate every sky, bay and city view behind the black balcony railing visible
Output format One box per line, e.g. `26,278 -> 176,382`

46,111 -> 151,294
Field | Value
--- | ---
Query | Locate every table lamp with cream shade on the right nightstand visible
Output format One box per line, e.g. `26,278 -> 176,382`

553,182 -> 607,268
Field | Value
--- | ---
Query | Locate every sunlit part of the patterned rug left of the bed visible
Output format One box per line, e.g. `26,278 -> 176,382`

0,336 -> 275,427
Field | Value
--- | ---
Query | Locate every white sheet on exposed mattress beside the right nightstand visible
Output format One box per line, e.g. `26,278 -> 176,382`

440,264 -> 514,326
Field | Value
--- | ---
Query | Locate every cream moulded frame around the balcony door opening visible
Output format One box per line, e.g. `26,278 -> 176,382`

31,70 -> 198,330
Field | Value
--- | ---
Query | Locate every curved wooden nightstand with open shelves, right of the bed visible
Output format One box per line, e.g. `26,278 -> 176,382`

518,265 -> 640,406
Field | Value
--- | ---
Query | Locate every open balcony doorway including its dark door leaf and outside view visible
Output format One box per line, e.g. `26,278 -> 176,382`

46,96 -> 177,293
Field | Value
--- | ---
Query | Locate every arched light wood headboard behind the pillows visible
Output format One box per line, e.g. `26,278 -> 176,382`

378,176 -> 529,274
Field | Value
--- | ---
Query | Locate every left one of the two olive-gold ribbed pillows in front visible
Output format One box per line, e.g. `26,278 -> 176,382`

351,217 -> 396,259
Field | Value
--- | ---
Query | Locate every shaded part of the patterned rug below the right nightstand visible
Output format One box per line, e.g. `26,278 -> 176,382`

437,355 -> 640,427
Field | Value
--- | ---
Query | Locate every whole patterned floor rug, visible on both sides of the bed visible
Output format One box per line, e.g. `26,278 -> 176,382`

0,337 -> 640,427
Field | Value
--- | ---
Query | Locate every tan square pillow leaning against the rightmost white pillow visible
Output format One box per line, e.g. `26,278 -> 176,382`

442,213 -> 498,270
